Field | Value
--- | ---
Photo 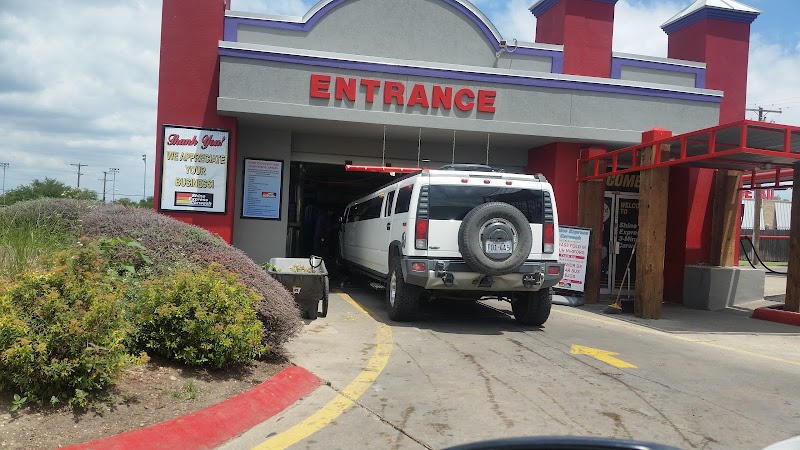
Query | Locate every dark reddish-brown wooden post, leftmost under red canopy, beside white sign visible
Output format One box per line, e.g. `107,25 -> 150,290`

578,148 -> 606,303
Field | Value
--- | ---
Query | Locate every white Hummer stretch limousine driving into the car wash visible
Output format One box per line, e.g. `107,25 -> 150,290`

339,164 -> 564,326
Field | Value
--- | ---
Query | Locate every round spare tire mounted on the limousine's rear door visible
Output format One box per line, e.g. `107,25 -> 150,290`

458,202 -> 533,275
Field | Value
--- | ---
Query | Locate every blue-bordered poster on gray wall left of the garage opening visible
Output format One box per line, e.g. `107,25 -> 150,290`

242,158 -> 283,220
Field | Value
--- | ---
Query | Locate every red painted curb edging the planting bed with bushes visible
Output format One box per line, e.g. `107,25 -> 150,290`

64,366 -> 321,450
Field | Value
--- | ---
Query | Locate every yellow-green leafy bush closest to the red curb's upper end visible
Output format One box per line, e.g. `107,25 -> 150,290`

129,264 -> 266,368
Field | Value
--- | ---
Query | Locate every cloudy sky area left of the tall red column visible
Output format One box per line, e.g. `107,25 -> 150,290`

0,0 -> 161,195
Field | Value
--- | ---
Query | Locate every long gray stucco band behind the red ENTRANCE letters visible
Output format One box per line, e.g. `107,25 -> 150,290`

218,57 -> 719,142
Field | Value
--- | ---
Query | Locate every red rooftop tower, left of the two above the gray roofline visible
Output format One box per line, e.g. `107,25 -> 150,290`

531,0 -> 616,78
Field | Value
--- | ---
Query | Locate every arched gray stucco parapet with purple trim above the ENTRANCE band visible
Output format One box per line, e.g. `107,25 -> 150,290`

238,0 -> 551,72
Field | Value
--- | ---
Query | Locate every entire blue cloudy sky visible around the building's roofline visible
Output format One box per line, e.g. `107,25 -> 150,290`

0,0 -> 800,200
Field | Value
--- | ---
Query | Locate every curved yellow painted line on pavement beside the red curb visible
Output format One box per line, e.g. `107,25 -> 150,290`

254,292 -> 394,450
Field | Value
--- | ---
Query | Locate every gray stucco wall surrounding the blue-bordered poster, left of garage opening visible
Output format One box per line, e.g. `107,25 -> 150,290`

233,125 -> 292,264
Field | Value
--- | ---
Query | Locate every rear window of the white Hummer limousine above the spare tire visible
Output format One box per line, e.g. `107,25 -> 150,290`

424,185 -> 544,223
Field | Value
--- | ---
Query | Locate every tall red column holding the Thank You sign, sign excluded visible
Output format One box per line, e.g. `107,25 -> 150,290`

154,0 -> 237,243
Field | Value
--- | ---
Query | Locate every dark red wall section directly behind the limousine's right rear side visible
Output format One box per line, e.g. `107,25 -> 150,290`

526,142 -> 585,226
